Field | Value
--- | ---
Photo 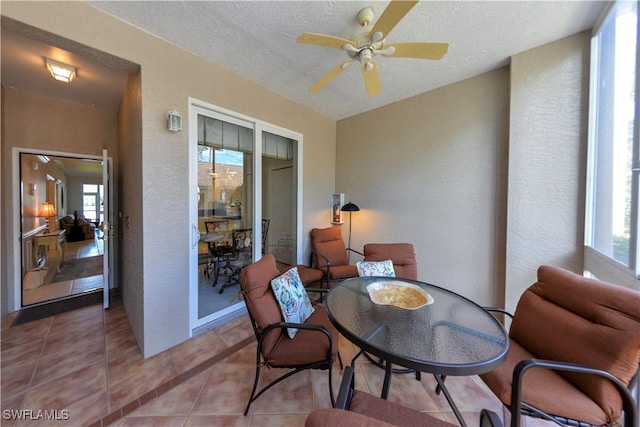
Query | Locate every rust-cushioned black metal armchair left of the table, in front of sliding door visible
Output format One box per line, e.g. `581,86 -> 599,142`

240,254 -> 343,415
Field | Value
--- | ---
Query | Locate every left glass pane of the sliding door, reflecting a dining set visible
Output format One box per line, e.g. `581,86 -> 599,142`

197,114 -> 254,319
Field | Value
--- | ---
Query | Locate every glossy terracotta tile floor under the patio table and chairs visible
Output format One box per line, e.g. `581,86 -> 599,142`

0,302 -> 556,427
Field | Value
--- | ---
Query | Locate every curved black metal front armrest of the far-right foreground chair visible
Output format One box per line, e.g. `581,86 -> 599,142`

511,359 -> 638,427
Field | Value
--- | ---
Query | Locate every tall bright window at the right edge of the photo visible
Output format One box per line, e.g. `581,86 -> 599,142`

585,1 -> 640,288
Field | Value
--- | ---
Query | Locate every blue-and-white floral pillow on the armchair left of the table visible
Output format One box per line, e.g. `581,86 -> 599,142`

271,267 -> 315,339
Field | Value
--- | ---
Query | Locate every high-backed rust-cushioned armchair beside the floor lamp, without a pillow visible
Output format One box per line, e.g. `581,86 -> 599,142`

309,226 -> 364,289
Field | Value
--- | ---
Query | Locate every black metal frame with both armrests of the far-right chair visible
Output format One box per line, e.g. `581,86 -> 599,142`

484,307 -> 640,427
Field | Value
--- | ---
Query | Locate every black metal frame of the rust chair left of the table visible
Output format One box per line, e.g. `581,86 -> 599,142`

242,289 -> 343,415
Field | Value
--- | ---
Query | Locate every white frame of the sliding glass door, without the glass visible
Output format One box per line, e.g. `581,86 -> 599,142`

188,97 -> 303,336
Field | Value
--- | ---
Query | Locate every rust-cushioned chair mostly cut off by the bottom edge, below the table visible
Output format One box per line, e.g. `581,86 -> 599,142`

305,365 -> 502,427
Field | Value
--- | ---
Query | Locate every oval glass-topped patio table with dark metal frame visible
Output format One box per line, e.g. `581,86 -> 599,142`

326,277 -> 509,426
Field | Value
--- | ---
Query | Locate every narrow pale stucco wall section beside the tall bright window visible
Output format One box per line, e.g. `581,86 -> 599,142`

506,32 -> 590,310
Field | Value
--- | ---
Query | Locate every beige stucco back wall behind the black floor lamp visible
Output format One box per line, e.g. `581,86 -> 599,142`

336,68 -> 509,304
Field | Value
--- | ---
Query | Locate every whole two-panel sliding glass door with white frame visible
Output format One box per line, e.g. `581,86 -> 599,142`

189,100 -> 301,333
